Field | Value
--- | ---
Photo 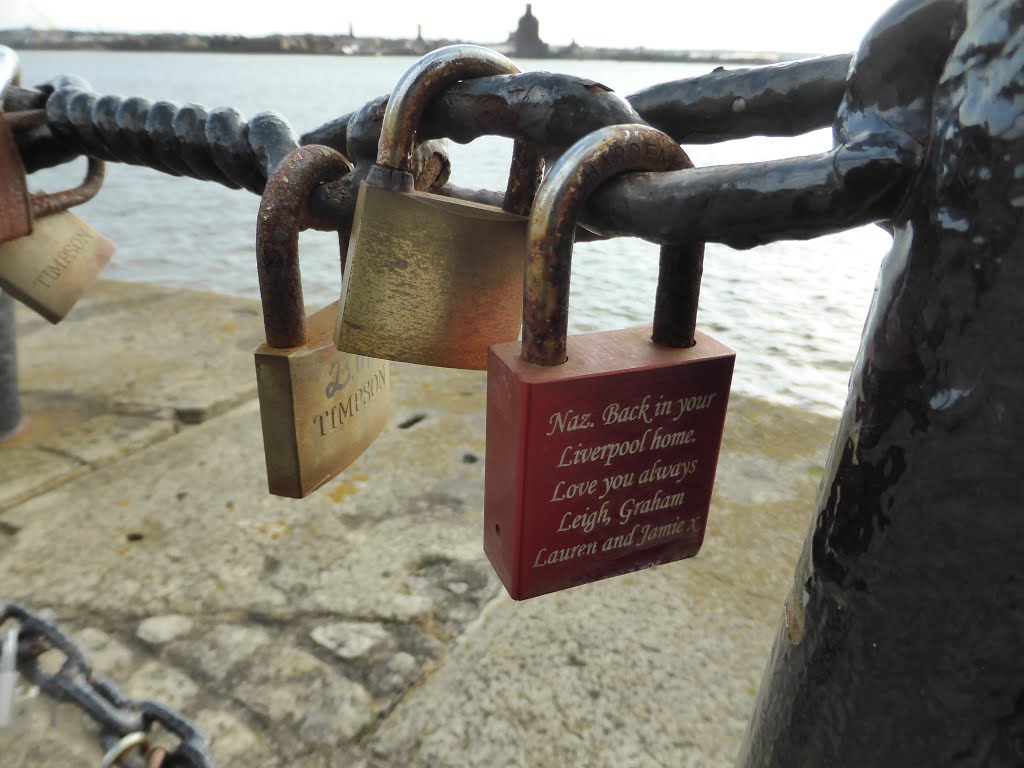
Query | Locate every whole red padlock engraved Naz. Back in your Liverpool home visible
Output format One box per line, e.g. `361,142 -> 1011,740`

483,125 -> 735,600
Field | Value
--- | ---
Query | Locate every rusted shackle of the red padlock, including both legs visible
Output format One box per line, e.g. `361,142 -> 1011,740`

522,125 -> 703,366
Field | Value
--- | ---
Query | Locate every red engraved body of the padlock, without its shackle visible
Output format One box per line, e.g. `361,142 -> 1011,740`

484,328 -> 735,599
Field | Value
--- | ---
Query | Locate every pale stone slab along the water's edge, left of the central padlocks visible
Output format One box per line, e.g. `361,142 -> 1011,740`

16,281 -> 263,423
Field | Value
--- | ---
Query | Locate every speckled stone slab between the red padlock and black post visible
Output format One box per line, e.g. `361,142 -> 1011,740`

368,398 -> 827,768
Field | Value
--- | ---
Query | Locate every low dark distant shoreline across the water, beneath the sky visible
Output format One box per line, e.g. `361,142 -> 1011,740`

0,29 -> 814,66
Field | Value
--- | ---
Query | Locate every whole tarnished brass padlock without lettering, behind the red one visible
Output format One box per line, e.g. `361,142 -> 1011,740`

335,45 -> 543,370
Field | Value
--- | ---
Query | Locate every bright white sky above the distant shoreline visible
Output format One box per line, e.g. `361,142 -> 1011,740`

6,0 -> 905,53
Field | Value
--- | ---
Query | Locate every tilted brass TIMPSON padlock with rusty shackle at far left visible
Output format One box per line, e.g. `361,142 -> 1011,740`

0,158 -> 115,323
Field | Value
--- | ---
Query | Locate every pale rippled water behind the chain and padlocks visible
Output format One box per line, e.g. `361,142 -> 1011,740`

22,51 -> 890,415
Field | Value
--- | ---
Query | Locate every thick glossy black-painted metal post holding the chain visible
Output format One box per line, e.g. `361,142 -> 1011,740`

738,0 -> 1024,768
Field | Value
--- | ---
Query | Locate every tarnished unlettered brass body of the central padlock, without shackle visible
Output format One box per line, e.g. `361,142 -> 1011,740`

337,183 -> 526,370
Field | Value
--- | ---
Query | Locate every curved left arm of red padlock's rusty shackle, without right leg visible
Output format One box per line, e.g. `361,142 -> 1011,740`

522,125 -> 693,366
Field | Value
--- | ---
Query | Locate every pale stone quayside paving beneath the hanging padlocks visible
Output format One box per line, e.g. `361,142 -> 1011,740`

0,282 -> 834,768
